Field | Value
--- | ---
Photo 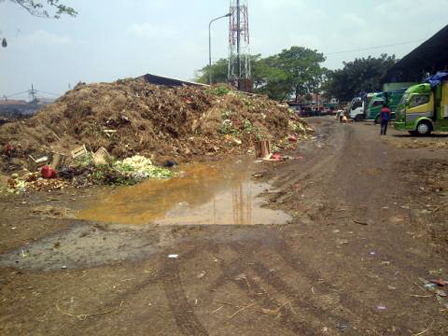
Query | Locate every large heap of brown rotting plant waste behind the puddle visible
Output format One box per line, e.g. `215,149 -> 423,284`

0,79 -> 312,170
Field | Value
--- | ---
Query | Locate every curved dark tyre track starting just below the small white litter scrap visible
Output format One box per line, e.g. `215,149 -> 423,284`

162,260 -> 208,336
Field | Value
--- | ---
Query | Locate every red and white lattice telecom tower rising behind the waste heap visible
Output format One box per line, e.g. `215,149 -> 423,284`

228,0 -> 252,92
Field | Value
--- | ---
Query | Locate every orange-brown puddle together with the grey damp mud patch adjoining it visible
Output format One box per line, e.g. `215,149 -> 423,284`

0,160 -> 290,271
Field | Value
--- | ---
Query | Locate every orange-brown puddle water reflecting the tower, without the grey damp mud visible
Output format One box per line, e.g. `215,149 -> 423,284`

77,160 -> 291,225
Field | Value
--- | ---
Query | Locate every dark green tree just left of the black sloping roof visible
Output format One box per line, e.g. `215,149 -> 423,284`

324,54 -> 397,101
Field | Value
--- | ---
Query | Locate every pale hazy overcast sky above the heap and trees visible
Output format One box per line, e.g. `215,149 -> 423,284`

0,0 -> 448,98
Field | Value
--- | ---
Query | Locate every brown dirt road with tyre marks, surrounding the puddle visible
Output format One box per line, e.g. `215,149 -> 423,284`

0,118 -> 448,336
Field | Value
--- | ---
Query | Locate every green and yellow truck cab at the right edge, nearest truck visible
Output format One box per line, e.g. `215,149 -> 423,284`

394,72 -> 448,135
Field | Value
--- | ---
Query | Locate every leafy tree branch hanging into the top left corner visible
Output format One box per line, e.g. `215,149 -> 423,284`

7,0 -> 78,19
